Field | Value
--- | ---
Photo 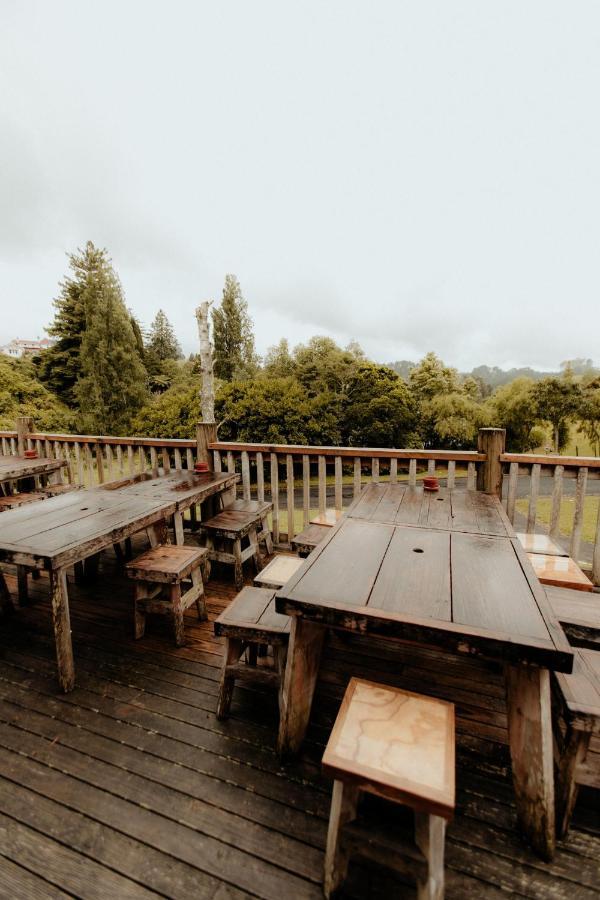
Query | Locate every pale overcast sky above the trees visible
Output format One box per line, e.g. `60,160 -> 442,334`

0,0 -> 600,369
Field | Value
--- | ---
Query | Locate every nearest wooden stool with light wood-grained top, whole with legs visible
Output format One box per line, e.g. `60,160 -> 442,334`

323,678 -> 454,900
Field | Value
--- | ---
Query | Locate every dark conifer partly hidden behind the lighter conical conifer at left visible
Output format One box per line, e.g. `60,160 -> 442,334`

39,241 -> 106,406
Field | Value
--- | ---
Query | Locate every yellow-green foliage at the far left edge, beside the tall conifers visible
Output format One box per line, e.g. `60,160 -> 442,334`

0,354 -> 75,432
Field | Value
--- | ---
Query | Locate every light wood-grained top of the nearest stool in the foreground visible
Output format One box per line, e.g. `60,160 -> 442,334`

323,678 -> 455,818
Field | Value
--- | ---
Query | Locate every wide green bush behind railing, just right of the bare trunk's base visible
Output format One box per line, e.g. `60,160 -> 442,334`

215,377 -> 340,444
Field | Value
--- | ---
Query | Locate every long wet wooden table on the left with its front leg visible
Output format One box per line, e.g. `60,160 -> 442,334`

0,471 -> 238,691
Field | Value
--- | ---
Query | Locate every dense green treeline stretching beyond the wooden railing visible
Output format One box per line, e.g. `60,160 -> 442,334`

0,242 -> 600,453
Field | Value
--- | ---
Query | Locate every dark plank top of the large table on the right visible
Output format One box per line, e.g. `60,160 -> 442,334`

276,484 -> 573,672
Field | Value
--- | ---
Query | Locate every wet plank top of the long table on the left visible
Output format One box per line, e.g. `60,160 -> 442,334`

0,471 -> 238,568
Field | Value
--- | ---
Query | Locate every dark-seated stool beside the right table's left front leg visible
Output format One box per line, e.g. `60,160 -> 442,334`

215,587 -> 291,719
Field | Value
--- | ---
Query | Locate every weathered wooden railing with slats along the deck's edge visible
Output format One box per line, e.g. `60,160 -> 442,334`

0,431 -> 600,585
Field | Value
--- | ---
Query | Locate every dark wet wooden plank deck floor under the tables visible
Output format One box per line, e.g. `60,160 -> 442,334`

0,540 -> 600,900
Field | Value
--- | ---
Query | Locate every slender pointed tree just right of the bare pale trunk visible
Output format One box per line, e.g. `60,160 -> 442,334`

211,275 -> 258,381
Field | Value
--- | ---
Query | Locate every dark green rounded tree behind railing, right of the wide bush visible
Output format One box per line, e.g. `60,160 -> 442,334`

341,362 -> 417,447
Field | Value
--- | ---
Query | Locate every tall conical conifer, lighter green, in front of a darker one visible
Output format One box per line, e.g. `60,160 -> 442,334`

75,245 -> 147,434
